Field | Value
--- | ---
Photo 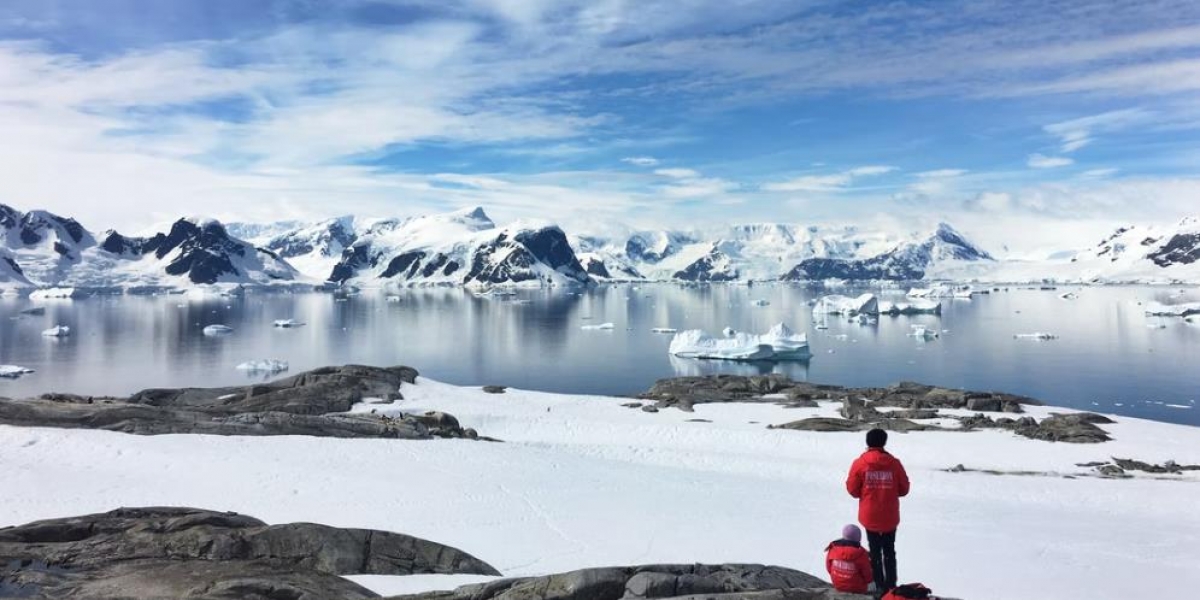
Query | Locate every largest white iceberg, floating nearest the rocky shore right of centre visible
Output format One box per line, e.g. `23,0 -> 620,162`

667,323 -> 812,360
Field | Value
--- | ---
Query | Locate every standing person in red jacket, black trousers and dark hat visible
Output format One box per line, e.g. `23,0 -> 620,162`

846,428 -> 908,592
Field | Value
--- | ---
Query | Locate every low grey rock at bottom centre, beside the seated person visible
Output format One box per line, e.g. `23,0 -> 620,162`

392,564 -> 870,600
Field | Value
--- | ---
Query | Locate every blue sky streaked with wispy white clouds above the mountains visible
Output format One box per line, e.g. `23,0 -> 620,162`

0,0 -> 1200,256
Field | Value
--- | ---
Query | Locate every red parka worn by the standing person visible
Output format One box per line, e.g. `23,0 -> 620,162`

846,448 -> 908,533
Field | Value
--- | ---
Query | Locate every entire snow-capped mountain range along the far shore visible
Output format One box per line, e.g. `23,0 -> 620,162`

0,205 -> 1200,293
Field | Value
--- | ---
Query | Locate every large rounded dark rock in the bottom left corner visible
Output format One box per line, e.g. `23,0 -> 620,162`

0,508 -> 499,600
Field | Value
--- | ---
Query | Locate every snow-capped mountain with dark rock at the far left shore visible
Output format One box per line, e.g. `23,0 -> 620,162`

0,205 -> 300,289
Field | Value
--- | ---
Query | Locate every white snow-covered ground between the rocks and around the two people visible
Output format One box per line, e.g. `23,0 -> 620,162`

0,378 -> 1200,600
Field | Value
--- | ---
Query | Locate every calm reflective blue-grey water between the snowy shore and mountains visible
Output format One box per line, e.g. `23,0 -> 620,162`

0,284 -> 1200,425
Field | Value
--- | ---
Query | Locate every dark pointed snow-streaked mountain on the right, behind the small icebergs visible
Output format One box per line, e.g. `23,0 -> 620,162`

782,223 -> 995,281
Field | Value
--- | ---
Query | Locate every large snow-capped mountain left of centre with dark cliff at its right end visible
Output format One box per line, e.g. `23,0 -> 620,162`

329,208 -> 592,286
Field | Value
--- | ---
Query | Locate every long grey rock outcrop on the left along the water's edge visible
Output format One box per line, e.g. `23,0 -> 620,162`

0,365 -> 487,439
